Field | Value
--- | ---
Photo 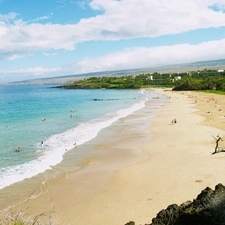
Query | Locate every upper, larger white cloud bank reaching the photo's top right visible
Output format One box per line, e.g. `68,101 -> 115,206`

0,0 -> 225,59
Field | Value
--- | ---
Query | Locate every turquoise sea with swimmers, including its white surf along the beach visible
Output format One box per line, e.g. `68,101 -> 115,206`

0,85 -> 162,189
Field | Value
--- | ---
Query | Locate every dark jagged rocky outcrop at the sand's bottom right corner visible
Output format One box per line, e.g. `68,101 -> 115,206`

126,184 -> 225,225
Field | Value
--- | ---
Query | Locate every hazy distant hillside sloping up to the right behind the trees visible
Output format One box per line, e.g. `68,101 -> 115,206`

3,59 -> 225,85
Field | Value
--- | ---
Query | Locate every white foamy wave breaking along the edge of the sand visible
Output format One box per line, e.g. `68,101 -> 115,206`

0,93 -> 147,189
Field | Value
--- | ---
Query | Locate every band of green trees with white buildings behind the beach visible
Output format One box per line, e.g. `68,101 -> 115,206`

60,69 -> 225,92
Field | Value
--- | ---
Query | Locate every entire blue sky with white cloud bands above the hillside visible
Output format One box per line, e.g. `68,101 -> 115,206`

0,0 -> 225,83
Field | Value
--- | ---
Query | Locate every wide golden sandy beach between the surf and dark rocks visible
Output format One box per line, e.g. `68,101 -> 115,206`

3,89 -> 225,225
